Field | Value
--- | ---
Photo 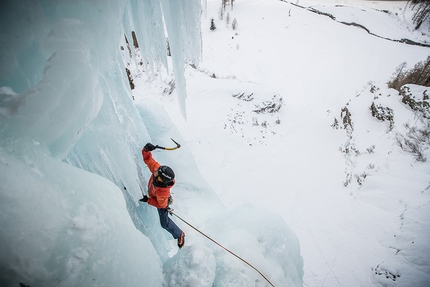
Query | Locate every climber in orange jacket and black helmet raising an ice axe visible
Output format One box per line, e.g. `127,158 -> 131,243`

139,143 -> 185,248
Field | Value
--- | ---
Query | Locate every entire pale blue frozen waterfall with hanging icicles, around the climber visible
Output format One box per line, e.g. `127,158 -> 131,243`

0,0 -> 303,287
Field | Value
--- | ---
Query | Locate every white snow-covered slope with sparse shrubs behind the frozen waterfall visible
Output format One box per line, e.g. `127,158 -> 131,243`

133,0 -> 430,286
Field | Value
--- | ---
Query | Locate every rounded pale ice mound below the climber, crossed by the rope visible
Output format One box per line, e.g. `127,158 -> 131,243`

164,205 -> 303,286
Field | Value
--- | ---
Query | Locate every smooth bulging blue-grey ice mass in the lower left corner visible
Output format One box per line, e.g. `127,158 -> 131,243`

0,143 -> 163,287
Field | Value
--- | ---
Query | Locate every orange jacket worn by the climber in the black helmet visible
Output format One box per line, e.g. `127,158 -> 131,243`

142,149 -> 175,208
